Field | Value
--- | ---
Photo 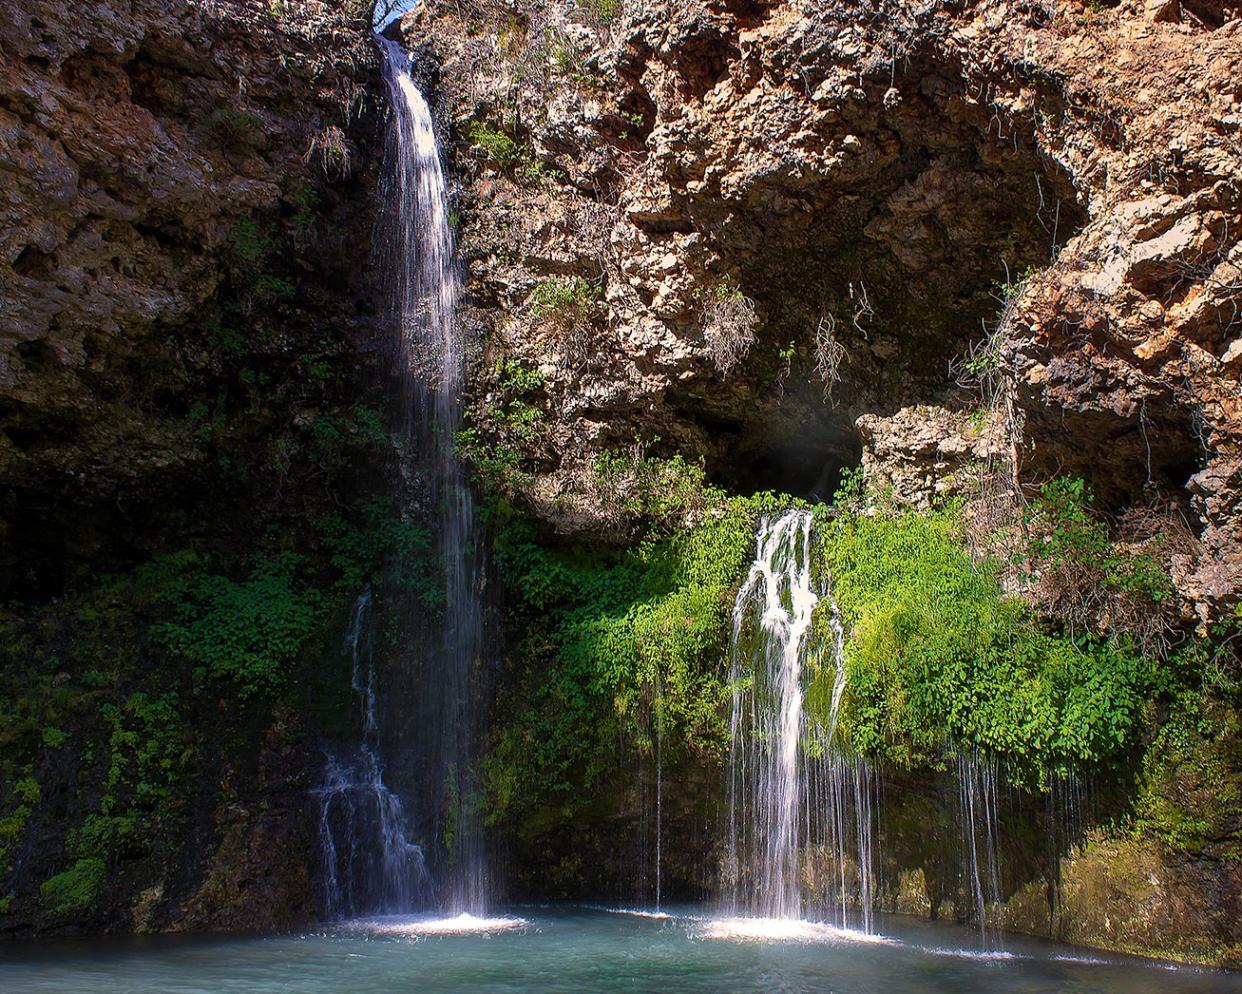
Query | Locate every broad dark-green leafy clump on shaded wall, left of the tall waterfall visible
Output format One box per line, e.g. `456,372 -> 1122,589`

152,552 -> 322,698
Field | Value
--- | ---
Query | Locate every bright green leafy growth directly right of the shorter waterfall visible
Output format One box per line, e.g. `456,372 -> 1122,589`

811,508 -> 1154,783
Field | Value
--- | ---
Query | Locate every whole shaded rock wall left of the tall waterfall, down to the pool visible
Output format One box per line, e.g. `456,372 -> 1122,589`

0,0 -> 386,932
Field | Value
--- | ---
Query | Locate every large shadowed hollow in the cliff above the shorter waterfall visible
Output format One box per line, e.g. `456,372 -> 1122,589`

668,46 -> 1087,499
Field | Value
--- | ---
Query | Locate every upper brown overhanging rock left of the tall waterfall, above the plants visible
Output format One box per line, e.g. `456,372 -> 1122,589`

0,0 -> 378,586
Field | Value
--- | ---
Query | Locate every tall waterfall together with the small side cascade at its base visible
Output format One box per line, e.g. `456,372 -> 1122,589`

317,34 -> 488,916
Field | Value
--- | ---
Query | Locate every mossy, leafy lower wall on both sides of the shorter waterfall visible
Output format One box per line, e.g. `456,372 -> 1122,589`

476,464 -> 1242,962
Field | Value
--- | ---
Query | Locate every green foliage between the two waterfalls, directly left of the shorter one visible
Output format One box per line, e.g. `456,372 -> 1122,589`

487,497 -> 773,830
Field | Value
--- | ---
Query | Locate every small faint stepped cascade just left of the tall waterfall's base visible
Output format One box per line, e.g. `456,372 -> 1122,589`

314,589 -> 431,919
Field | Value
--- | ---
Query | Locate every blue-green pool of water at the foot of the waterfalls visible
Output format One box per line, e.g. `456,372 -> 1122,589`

0,907 -> 1242,994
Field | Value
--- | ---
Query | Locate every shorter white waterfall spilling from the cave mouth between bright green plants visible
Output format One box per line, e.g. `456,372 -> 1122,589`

727,509 -> 874,929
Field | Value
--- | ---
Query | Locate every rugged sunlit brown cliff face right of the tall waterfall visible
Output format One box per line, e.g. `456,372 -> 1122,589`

405,0 -> 1242,613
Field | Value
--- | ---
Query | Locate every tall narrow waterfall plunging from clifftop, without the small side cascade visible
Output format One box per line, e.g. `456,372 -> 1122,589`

375,34 -> 488,911
